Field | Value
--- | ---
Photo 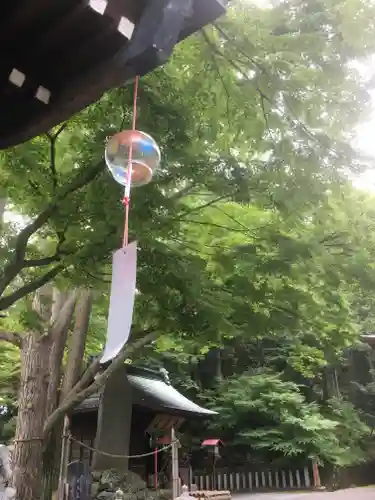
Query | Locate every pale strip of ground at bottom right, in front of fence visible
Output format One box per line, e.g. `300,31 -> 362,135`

233,486 -> 375,500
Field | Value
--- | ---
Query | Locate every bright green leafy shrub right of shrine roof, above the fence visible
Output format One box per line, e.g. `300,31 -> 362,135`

207,371 -> 369,466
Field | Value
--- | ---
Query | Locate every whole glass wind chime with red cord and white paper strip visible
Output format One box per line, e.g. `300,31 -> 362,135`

101,76 -> 161,363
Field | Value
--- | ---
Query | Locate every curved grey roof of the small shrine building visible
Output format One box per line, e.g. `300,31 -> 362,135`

76,366 -> 216,417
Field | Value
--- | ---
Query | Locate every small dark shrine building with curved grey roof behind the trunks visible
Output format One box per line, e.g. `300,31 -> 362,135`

70,365 -> 216,480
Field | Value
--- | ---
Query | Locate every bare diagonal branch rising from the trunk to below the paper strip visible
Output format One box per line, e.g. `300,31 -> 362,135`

44,330 -> 159,436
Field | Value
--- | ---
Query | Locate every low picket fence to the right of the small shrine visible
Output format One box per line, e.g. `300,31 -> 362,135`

194,465 -> 314,492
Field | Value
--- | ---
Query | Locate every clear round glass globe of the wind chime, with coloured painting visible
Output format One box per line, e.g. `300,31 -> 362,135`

105,130 -> 161,187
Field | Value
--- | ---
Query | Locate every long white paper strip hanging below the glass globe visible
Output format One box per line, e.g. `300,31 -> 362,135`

100,241 -> 137,363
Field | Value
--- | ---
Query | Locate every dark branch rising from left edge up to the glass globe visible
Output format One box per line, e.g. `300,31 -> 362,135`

0,160 -> 105,296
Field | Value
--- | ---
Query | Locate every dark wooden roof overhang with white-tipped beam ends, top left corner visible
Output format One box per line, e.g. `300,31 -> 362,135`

0,0 -> 225,148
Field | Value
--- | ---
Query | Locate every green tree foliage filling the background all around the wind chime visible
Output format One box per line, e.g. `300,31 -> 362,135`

0,0 -> 375,488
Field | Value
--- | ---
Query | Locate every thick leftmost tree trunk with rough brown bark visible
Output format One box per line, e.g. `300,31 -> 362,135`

13,333 -> 50,500
